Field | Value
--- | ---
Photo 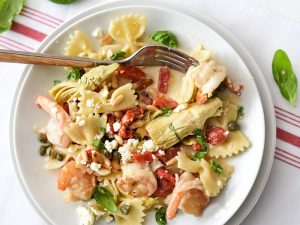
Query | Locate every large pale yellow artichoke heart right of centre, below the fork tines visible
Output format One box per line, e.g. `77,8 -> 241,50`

146,98 -> 222,149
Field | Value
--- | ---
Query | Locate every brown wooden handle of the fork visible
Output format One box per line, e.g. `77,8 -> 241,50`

0,49 -> 97,68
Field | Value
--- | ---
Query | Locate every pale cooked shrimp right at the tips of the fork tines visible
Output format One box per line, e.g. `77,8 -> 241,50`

186,60 -> 226,99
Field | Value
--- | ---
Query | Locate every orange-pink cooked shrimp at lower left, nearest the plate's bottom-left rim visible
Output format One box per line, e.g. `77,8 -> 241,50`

57,161 -> 96,201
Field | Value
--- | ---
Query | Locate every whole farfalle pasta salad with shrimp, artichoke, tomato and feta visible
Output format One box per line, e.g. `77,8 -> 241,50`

36,14 -> 250,225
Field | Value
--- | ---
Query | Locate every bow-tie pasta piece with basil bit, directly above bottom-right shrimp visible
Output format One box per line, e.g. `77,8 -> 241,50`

200,159 -> 234,197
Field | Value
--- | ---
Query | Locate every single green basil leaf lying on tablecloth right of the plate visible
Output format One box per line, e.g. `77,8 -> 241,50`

272,49 -> 297,106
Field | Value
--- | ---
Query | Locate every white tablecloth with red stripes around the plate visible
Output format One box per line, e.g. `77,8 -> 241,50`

0,0 -> 300,225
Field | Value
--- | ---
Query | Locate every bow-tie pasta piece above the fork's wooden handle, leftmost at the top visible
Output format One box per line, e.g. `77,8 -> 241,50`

65,30 -> 93,56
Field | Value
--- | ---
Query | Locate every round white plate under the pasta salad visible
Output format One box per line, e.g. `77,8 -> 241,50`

11,1 -> 274,224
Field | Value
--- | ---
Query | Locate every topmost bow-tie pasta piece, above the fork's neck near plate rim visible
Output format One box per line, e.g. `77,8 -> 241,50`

108,14 -> 146,54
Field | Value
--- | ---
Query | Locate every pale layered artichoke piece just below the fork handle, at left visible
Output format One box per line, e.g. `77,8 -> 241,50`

49,63 -> 119,103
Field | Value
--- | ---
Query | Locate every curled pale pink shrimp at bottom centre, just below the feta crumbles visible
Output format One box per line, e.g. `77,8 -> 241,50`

117,163 -> 157,197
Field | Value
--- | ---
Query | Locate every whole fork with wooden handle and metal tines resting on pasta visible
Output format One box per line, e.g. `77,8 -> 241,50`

0,45 -> 199,73
